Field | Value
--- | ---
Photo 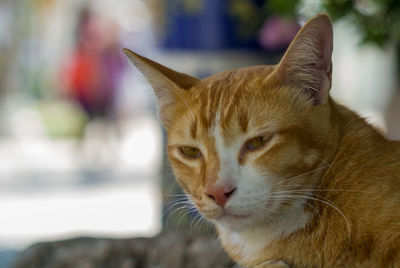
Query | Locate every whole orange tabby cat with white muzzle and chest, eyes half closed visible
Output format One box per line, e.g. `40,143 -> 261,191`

125,15 -> 400,267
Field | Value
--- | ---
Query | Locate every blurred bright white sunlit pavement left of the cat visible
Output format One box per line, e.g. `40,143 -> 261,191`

0,116 -> 162,249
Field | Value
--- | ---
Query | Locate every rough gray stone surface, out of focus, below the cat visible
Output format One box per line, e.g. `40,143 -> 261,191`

14,232 -> 236,268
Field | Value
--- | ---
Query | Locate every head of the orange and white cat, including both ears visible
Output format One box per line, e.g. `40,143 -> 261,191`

125,15 -> 332,229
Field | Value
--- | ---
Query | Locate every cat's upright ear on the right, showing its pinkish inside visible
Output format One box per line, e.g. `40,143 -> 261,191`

274,14 -> 333,105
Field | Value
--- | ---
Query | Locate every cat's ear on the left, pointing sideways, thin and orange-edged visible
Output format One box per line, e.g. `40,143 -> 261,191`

123,48 -> 199,125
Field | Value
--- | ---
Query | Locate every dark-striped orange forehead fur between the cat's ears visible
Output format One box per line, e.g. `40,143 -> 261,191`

191,66 -> 273,136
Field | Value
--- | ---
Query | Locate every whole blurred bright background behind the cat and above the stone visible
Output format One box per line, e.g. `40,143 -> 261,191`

0,0 -> 400,267
